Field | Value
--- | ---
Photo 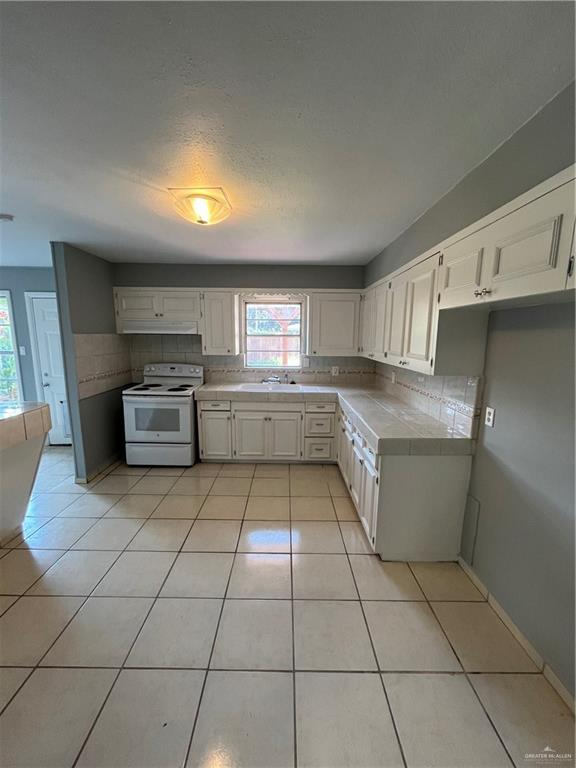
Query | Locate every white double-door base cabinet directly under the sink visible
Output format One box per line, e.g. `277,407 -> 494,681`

232,403 -> 303,461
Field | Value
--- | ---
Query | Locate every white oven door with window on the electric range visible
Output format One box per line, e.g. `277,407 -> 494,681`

123,395 -> 193,443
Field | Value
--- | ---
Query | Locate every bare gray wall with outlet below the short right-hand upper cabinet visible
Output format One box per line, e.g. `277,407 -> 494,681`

470,303 -> 574,692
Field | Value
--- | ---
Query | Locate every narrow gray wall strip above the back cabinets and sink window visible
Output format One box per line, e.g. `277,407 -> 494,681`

112,264 -> 364,289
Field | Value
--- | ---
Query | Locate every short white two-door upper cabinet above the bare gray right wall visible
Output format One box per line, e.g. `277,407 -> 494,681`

440,181 -> 574,309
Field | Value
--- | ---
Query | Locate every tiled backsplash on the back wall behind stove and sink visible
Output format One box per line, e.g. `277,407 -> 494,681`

127,334 -> 374,386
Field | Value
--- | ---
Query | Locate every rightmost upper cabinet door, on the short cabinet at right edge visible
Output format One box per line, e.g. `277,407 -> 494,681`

482,181 -> 574,301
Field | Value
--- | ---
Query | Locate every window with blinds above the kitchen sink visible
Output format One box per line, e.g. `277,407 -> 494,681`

244,300 -> 304,368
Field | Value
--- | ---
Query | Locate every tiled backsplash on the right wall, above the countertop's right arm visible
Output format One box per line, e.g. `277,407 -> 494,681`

375,363 -> 482,437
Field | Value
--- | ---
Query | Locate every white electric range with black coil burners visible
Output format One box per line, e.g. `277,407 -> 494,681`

122,363 -> 204,466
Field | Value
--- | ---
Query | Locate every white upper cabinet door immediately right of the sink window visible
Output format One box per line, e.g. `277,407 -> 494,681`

309,293 -> 360,357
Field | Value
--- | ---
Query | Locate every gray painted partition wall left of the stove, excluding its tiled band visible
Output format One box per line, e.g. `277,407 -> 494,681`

52,243 -> 124,480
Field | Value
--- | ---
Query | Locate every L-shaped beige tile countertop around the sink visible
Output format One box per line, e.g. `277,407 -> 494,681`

194,384 -> 475,456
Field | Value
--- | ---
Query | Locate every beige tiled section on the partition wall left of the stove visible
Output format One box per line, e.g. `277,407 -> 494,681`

74,333 -> 132,400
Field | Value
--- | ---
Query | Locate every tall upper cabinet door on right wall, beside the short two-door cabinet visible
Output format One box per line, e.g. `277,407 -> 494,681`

403,256 -> 438,372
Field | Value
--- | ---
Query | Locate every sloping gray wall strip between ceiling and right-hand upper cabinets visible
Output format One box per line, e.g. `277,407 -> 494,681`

364,83 -> 574,285
